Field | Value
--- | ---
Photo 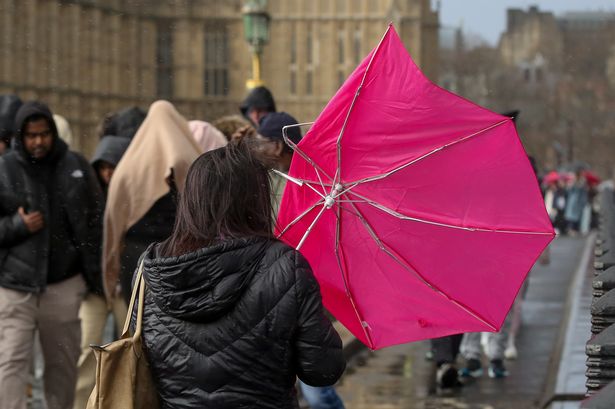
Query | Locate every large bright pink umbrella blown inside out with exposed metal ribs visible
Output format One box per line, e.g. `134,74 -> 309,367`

278,26 -> 554,349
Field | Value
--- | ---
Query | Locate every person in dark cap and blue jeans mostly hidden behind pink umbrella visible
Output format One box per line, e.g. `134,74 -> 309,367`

255,112 -> 344,409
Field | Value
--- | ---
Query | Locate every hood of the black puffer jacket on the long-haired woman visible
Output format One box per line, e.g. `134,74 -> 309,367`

143,237 -> 269,322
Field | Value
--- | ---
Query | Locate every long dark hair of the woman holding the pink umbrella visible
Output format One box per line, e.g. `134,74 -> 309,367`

160,142 -> 273,257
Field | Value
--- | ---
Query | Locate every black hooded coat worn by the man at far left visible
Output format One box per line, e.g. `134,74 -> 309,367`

0,101 -> 103,293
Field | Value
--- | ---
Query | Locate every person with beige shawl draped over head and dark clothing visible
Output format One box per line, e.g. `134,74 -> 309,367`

103,101 -> 201,304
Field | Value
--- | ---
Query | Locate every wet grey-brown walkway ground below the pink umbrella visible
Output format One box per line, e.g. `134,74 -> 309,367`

337,237 -> 585,409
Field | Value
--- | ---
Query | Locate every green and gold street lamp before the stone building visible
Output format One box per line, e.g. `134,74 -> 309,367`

241,0 -> 270,89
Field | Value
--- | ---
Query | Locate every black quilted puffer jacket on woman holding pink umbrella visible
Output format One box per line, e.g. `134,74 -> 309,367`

138,238 -> 345,409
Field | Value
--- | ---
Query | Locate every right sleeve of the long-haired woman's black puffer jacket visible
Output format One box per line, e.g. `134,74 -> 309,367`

295,252 -> 346,386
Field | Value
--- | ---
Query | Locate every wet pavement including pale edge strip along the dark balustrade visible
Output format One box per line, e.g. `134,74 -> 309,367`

337,236 -> 593,409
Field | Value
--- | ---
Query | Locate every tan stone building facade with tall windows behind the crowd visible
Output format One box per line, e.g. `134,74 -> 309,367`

0,0 -> 438,154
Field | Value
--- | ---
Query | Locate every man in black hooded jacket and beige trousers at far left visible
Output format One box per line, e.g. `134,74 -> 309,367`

0,101 -> 102,409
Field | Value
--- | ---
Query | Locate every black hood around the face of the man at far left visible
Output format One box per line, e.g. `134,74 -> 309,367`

13,101 -> 68,163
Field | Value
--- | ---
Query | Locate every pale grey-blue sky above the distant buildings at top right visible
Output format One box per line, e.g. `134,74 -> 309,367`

440,0 -> 615,44
